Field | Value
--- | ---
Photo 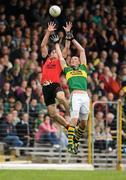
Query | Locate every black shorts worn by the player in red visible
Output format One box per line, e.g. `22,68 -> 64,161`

42,83 -> 63,106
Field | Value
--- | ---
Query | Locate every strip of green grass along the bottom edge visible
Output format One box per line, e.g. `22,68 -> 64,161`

0,170 -> 126,180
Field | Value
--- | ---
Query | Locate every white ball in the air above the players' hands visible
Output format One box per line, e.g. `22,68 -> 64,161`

49,5 -> 61,17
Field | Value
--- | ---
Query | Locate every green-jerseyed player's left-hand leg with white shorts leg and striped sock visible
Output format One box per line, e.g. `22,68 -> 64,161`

68,94 -> 80,154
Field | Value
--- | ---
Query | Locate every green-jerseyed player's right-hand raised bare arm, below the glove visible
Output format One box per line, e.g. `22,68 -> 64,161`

72,39 -> 87,65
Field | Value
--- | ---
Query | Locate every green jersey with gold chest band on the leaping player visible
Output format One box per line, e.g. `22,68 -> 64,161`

64,64 -> 87,92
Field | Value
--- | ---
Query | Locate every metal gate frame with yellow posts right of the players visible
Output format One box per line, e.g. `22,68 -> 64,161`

88,101 -> 124,170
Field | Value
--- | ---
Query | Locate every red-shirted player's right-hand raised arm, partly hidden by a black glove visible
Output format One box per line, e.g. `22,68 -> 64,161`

62,22 -> 72,58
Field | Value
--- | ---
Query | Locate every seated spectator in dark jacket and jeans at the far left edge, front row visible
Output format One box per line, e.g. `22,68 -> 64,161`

0,113 -> 23,147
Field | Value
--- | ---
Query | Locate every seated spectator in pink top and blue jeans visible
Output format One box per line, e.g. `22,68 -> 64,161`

35,114 -> 59,145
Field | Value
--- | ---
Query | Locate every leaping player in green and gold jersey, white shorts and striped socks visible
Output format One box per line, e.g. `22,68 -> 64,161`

51,32 -> 90,154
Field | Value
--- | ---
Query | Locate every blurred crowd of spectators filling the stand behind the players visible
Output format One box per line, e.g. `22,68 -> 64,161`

0,0 -> 126,149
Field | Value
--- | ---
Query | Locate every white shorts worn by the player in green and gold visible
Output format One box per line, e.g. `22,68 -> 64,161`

70,92 -> 90,120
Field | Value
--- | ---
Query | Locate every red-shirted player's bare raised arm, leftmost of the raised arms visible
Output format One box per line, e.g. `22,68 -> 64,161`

41,22 -> 56,57
